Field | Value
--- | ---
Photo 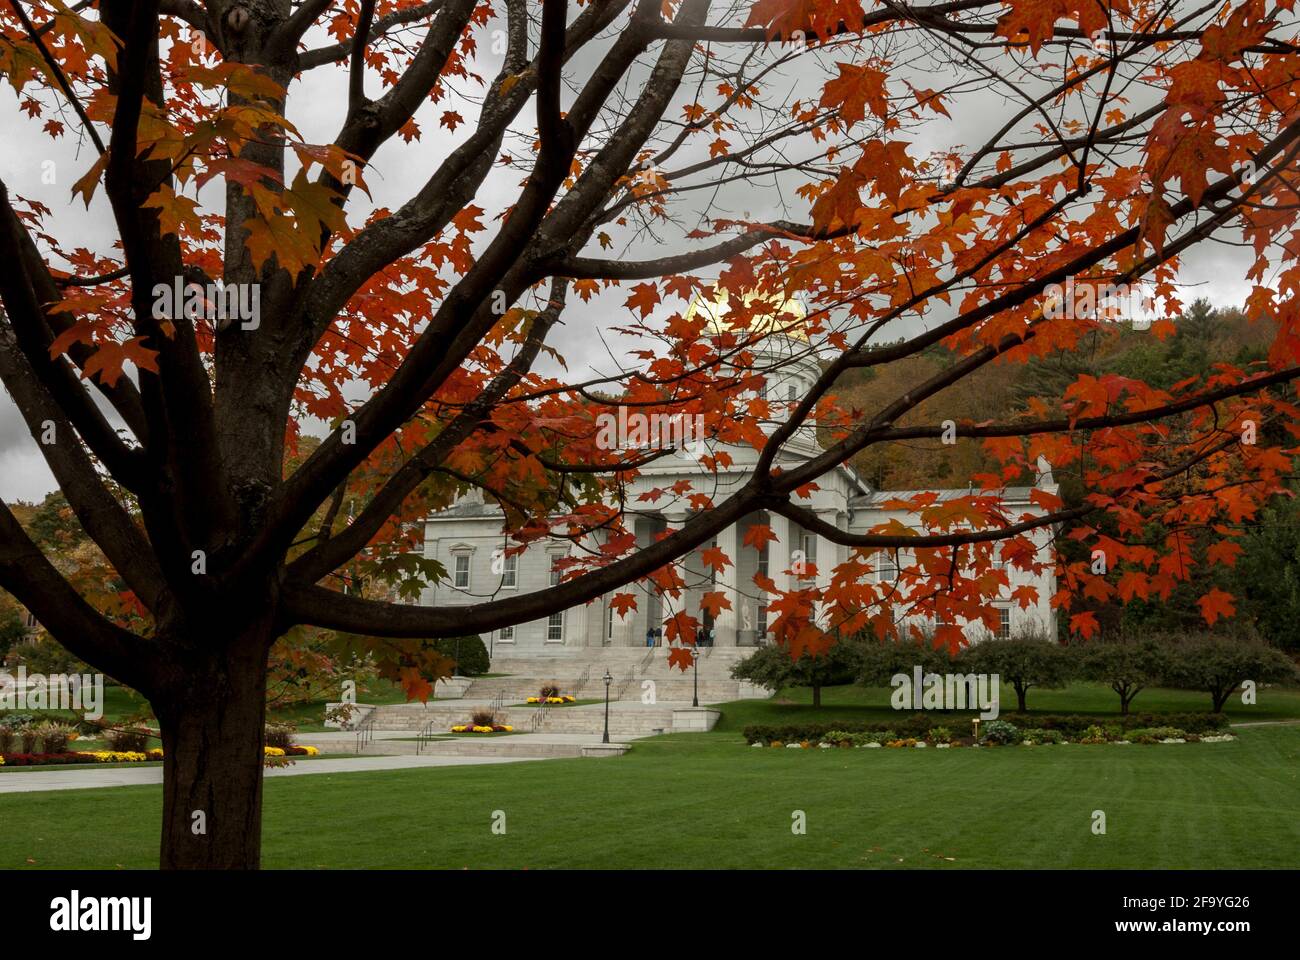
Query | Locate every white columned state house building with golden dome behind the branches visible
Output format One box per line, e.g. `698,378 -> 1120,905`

420,287 -> 1057,658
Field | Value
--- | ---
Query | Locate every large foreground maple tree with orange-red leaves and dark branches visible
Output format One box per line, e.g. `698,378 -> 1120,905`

0,0 -> 1300,868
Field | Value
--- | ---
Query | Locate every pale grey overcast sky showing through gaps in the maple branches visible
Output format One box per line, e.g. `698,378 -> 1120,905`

0,7 -> 1249,501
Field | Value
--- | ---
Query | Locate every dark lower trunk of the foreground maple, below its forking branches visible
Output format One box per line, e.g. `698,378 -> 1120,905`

153,631 -> 267,870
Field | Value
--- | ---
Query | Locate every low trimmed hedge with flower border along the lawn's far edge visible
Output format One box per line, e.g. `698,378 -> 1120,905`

742,710 -> 1227,743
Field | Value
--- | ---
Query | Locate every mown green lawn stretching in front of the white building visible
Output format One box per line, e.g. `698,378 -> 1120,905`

0,688 -> 1300,869
